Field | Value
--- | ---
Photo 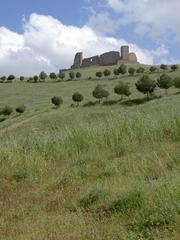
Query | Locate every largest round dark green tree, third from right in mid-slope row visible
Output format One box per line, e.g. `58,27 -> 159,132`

136,75 -> 156,97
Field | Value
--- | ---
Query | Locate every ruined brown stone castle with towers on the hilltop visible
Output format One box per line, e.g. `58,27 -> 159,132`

71,46 -> 138,69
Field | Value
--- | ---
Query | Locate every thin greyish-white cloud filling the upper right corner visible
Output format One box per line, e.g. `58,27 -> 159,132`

107,0 -> 180,44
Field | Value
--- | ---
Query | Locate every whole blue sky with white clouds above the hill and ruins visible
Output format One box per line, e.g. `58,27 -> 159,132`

0,0 -> 180,76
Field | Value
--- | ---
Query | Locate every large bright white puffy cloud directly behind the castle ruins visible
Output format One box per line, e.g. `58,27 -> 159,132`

0,14 -> 162,76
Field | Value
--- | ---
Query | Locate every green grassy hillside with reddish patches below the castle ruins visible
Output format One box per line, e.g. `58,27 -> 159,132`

0,64 -> 180,240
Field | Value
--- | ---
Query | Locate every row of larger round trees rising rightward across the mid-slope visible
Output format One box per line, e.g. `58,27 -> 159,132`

51,74 -> 180,107
